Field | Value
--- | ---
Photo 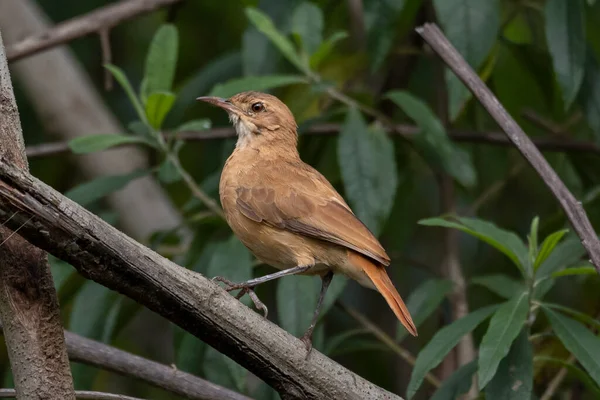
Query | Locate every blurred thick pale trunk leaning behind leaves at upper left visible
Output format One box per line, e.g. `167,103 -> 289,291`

0,0 -> 181,239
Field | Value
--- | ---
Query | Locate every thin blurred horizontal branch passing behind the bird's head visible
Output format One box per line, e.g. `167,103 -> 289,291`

26,123 -> 600,157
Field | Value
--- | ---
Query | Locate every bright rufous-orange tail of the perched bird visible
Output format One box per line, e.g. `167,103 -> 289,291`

348,251 -> 417,336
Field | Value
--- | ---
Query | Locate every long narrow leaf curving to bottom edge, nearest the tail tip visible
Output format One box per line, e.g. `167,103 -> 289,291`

406,305 -> 498,399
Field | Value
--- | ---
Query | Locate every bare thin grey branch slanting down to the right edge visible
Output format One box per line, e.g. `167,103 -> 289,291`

417,24 -> 600,274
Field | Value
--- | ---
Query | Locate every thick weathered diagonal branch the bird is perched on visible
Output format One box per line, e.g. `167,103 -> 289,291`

0,160 -> 398,399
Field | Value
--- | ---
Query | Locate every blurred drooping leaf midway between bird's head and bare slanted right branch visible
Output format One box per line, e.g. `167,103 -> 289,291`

387,91 -> 477,187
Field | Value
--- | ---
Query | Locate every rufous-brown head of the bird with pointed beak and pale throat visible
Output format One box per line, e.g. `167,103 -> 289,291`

197,92 -> 298,149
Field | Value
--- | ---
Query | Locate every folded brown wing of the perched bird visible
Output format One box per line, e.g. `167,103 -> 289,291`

236,159 -> 390,266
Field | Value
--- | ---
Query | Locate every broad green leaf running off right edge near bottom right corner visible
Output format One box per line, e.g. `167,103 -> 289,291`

544,308 -> 600,385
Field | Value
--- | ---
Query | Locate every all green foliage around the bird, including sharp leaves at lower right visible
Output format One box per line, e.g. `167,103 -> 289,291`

23,0 -> 600,400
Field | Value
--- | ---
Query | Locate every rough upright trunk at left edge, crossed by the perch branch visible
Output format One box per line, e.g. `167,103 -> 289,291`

0,30 -> 75,399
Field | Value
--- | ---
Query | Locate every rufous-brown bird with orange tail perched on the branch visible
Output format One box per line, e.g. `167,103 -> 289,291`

197,91 -> 417,357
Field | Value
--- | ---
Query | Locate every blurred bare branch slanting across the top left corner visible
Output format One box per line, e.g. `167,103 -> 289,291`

6,0 -> 181,62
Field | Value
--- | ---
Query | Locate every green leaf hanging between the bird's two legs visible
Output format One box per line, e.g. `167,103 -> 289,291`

277,276 -> 320,336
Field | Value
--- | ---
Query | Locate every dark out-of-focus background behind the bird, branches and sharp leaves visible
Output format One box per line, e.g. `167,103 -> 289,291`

0,0 -> 600,399
